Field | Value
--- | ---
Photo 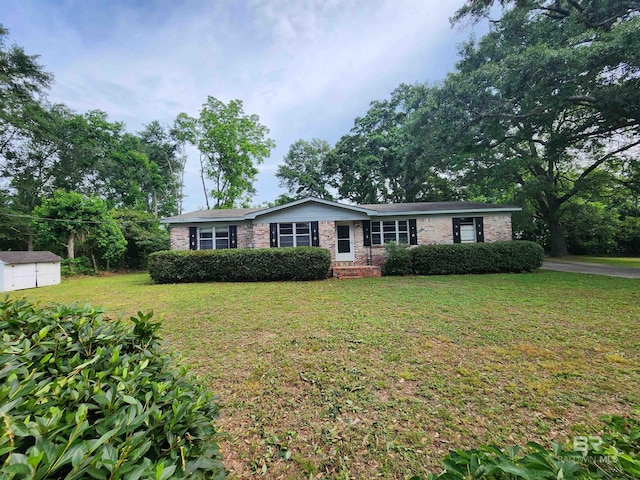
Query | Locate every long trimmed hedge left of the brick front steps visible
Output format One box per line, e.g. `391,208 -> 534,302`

149,247 -> 331,283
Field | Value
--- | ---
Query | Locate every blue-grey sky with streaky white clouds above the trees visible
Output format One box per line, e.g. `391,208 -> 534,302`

0,0 -> 484,211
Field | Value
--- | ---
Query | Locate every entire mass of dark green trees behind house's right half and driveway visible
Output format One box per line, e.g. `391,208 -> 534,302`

281,0 -> 640,255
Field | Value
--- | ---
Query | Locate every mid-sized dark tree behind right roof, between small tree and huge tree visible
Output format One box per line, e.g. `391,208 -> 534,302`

327,85 -> 457,203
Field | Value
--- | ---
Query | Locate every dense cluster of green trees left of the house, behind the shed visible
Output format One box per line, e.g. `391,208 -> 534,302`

0,26 -> 185,269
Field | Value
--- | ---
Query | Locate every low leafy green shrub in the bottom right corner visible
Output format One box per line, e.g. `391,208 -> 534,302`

424,410 -> 640,480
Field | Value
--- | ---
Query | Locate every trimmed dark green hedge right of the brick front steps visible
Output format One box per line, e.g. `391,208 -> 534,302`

410,241 -> 544,275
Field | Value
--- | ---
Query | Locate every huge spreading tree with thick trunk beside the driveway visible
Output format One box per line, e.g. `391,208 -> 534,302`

430,2 -> 640,256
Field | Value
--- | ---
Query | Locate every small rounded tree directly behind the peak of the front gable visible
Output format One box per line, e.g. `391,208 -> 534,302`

276,138 -> 333,200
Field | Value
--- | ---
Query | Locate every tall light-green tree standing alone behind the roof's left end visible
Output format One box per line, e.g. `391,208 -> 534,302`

180,97 -> 275,208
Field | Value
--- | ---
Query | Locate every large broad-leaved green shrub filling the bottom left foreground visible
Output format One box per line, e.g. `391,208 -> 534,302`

0,298 -> 227,480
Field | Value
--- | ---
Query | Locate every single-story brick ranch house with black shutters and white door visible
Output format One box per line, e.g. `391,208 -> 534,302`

162,197 -> 520,278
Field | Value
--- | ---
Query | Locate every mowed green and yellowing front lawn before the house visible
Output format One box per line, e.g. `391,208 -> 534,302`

7,271 -> 640,478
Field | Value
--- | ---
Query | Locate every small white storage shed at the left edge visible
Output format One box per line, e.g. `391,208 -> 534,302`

0,252 -> 62,292
